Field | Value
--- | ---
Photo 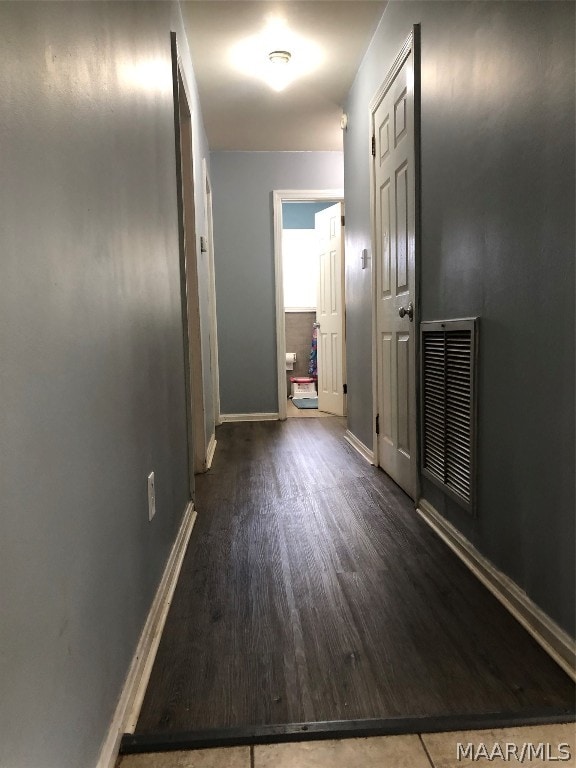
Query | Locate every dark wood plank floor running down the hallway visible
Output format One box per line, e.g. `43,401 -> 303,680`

136,418 -> 574,734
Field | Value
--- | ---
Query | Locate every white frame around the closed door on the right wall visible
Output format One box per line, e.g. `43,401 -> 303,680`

369,24 -> 420,486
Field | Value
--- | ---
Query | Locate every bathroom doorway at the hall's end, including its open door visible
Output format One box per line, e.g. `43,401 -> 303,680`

273,190 -> 346,420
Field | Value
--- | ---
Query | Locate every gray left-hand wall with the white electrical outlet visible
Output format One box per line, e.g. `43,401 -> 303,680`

0,2 -> 212,768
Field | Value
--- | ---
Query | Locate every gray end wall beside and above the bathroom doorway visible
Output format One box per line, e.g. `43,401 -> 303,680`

211,152 -> 343,414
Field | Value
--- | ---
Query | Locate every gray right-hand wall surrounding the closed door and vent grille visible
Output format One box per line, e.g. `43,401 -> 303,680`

345,2 -> 575,634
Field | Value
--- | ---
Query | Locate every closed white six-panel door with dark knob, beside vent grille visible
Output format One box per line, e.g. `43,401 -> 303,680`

373,43 -> 417,498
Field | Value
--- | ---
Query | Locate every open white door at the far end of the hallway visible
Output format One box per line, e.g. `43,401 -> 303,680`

315,203 -> 346,416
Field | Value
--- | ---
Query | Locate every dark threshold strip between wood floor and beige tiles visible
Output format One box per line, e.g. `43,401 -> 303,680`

120,708 -> 576,755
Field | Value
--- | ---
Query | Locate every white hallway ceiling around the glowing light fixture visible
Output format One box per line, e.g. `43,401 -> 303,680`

181,0 -> 386,151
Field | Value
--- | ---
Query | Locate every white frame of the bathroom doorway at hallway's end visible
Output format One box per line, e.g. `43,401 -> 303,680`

272,189 -> 344,421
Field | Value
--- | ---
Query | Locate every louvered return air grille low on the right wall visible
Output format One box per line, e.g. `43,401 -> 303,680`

420,319 -> 477,512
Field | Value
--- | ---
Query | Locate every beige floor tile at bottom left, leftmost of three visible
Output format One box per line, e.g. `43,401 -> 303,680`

117,747 -> 250,768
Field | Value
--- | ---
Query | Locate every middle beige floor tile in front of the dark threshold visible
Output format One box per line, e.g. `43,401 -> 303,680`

254,736 -> 430,768
